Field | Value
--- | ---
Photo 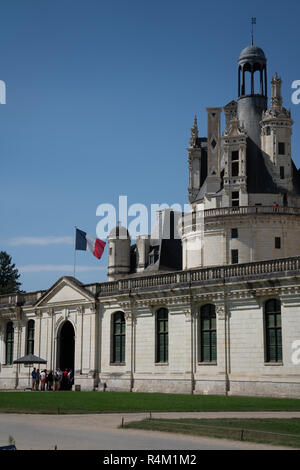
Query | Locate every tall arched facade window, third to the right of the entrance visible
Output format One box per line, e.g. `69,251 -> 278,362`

200,304 -> 217,362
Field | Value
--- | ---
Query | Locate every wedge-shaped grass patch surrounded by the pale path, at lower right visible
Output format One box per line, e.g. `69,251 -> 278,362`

123,418 -> 300,448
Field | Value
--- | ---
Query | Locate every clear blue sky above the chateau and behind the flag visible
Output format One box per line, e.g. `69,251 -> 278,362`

0,0 -> 300,291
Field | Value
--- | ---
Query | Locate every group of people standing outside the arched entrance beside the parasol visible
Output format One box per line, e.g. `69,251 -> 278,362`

31,367 -> 74,392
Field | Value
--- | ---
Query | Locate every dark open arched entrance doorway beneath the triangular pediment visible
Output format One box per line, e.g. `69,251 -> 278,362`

58,321 -> 75,373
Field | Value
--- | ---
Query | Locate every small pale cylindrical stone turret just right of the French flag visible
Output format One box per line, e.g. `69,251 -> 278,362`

107,223 -> 130,281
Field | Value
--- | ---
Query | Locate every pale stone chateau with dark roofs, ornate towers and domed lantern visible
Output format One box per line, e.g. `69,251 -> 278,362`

0,45 -> 300,397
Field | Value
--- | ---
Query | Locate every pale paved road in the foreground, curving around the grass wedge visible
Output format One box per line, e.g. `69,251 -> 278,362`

0,412 -> 300,450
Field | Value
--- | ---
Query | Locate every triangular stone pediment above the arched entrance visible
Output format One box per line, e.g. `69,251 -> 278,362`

35,276 -> 94,307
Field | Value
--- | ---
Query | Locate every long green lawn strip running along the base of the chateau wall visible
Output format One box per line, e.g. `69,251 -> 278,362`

0,391 -> 300,414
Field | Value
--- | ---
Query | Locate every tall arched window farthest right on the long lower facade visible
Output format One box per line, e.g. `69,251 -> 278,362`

265,299 -> 282,362
